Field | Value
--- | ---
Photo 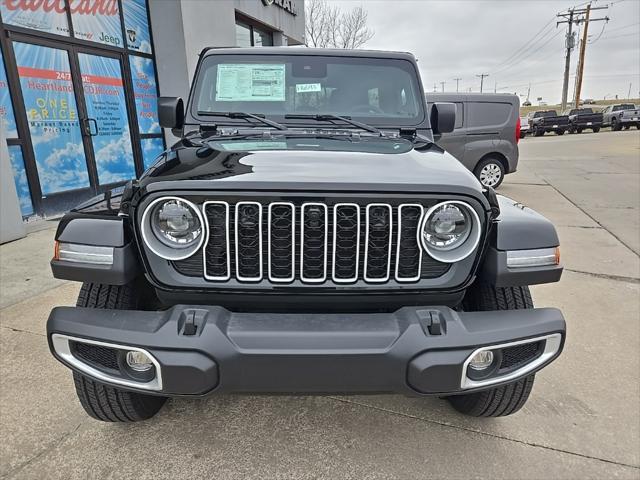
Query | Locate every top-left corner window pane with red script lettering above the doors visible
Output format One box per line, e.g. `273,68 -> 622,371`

0,0 -> 69,37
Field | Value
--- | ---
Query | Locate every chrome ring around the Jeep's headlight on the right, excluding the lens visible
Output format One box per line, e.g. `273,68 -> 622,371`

418,200 -> 482,263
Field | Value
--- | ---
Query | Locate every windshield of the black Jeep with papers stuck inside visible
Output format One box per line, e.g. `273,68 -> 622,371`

191,55 -> 424,128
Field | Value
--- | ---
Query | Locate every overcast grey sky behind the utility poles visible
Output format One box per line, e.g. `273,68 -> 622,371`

332,0 -> 640,104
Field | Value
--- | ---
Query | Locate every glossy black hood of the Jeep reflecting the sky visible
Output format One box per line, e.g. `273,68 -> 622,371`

139,136 -> 484,202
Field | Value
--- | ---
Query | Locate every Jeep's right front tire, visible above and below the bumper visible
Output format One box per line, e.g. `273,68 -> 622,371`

447,284 -> 535,417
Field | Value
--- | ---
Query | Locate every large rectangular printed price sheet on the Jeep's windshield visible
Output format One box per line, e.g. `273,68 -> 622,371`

216,64 -> 285,102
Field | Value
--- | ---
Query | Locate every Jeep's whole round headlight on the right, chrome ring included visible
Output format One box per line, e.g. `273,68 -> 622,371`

418,201 -> 480,263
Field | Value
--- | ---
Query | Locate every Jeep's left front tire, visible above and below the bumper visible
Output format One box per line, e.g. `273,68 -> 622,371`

73,283 -> 167,422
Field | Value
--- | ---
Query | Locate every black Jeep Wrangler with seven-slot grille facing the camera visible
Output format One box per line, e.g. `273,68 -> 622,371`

47,48 -> 565,422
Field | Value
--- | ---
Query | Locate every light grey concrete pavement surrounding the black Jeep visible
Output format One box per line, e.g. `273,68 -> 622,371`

0,130 -> 640,479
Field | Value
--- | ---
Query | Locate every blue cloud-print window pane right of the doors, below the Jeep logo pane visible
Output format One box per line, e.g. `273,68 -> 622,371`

129,55 -> 162,133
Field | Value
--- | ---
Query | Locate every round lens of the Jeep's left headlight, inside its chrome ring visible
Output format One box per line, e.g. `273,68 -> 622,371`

151,200 -> 202,248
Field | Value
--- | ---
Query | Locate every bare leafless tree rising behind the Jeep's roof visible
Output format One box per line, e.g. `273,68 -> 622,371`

305,0 -> 375,48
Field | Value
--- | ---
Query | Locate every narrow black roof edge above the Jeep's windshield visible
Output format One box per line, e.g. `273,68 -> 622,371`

200,47 -> 416,62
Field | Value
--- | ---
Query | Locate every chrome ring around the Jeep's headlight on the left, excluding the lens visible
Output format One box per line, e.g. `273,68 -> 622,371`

140,196 -> 209,261
